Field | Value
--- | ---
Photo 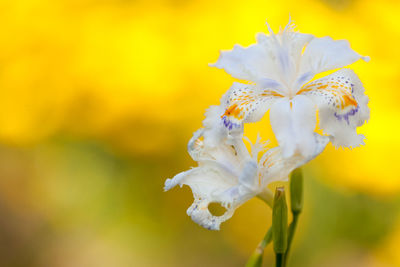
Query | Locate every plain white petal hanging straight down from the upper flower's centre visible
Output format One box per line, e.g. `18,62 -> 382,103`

270,95 -> 316,158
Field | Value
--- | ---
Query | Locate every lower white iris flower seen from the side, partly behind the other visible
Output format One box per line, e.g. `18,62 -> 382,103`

164,106 -> 329,230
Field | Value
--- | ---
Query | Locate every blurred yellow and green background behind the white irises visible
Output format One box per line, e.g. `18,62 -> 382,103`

0,0 -> 400,267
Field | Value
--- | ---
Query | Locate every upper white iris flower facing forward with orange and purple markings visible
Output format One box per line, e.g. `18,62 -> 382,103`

212,19 -> 369,157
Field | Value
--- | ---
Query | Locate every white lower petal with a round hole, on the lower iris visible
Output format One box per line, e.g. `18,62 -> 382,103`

164,160 -> 259,230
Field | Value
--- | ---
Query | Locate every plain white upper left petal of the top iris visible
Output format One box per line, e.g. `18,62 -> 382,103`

210,44 -> 279,82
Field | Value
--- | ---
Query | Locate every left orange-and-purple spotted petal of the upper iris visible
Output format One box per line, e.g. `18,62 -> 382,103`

222,82 -> 283,130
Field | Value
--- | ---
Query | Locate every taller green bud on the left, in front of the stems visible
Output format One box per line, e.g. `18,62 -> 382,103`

272,187 -> 288,254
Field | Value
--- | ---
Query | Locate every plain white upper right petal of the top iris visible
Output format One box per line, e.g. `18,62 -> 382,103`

299,37 -> 369,85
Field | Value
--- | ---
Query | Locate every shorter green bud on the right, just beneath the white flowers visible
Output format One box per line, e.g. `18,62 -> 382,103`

290,168 -> 303,214
